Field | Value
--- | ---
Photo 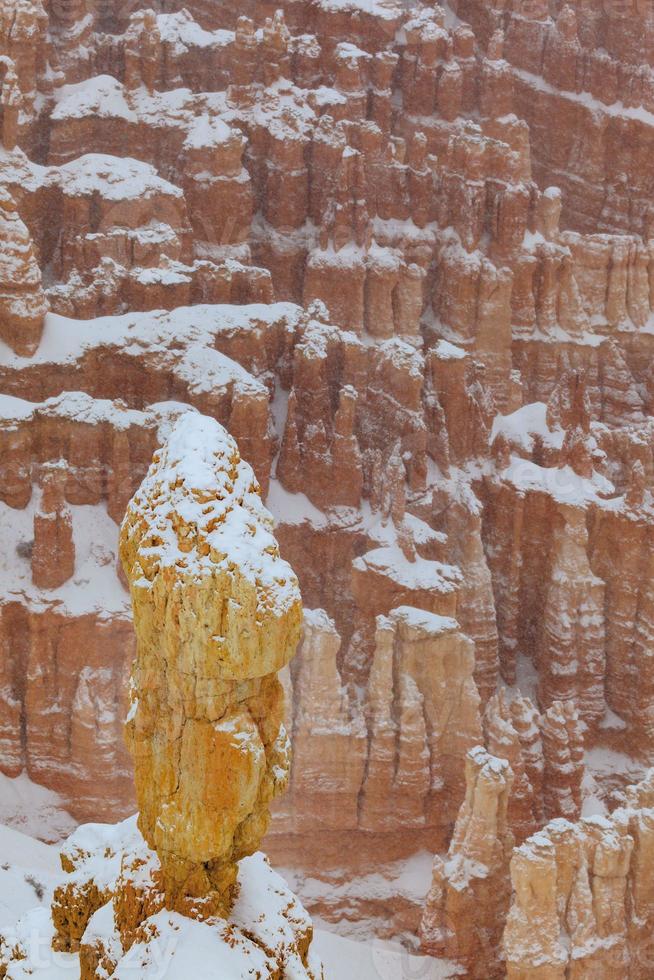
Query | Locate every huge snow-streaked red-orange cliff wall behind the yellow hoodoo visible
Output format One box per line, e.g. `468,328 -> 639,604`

0,0 -> 654,963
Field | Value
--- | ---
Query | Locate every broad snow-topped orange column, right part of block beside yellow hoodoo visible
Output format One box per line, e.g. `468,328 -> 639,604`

359,606 -> 482,838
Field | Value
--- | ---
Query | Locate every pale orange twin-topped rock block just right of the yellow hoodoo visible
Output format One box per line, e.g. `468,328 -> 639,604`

276,606 -> 482,839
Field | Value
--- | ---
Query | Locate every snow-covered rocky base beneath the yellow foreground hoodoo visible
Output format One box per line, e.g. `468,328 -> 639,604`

0,817 -> 323,980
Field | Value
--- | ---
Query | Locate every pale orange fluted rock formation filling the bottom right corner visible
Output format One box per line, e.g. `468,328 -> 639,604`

504,770 -> 654,978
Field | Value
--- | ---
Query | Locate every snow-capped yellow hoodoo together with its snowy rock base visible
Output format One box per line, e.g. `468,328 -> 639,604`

0,413 -> 323,980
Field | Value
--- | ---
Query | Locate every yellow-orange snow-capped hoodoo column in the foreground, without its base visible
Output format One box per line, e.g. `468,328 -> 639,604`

120,413 -> 302,915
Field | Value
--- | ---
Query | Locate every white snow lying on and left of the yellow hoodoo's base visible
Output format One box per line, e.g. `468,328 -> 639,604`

0,817 -> 319,980
